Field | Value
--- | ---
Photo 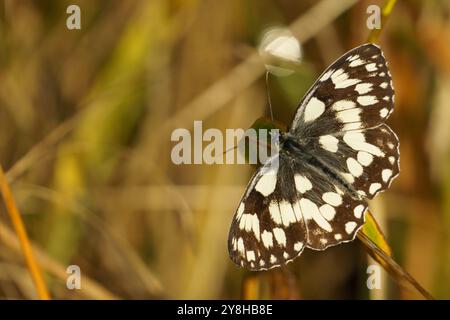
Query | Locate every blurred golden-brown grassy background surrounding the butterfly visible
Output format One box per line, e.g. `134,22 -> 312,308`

0,0 -> 450,299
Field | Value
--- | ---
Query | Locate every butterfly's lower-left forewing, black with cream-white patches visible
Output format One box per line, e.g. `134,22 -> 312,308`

228,154 -> 306,270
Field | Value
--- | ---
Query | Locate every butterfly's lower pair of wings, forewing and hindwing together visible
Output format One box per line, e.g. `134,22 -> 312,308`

228,151 -> 367,271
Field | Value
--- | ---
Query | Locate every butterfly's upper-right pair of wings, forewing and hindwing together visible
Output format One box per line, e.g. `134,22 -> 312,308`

290,44 -> 400,199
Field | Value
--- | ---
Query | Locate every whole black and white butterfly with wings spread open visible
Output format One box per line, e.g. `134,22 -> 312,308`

228,44 -> 399,271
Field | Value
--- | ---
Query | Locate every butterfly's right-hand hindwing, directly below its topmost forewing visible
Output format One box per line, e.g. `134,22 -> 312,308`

308,124 -> 400,199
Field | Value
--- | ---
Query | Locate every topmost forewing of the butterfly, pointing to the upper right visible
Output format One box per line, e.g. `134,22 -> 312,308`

290,44 -> 394,138
